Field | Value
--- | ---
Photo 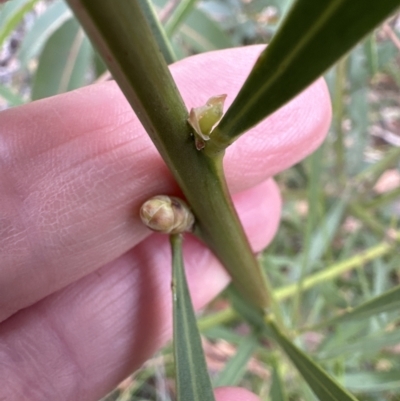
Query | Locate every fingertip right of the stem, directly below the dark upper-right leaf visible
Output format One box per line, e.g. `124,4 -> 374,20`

224,78 -> 332,191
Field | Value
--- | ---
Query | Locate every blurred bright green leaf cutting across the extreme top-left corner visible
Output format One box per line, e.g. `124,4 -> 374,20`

0,0 -> 38,47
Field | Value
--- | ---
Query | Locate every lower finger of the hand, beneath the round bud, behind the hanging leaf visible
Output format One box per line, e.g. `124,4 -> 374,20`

0,181 -> 280,401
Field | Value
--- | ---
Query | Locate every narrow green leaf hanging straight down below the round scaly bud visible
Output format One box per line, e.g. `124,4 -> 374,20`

171,234 -> 215,401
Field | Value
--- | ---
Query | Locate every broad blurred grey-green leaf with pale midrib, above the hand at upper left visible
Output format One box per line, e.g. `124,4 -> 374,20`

31,19 -> 92,100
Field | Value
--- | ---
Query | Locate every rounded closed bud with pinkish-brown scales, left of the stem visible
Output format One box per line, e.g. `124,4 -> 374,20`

140,195 -> 194,234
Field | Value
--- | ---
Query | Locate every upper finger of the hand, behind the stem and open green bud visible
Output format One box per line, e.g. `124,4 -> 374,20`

0,47 -> 330,319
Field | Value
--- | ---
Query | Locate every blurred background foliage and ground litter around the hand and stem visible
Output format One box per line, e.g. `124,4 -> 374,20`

0,0 -> 400,401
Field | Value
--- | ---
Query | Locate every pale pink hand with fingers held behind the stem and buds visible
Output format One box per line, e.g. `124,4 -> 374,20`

0,46 -> 331,401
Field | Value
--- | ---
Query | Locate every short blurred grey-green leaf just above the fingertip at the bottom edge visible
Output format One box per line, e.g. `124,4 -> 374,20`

214,335 -> 258,387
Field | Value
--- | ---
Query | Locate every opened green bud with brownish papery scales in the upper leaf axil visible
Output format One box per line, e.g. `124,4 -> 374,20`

188,95 -> 226,150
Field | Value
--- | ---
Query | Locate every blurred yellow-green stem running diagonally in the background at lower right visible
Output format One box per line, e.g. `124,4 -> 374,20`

199,232 -> 400,331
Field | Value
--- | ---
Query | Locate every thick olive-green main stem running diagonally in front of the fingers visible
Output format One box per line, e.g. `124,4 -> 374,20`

68,0 -> 269,310
